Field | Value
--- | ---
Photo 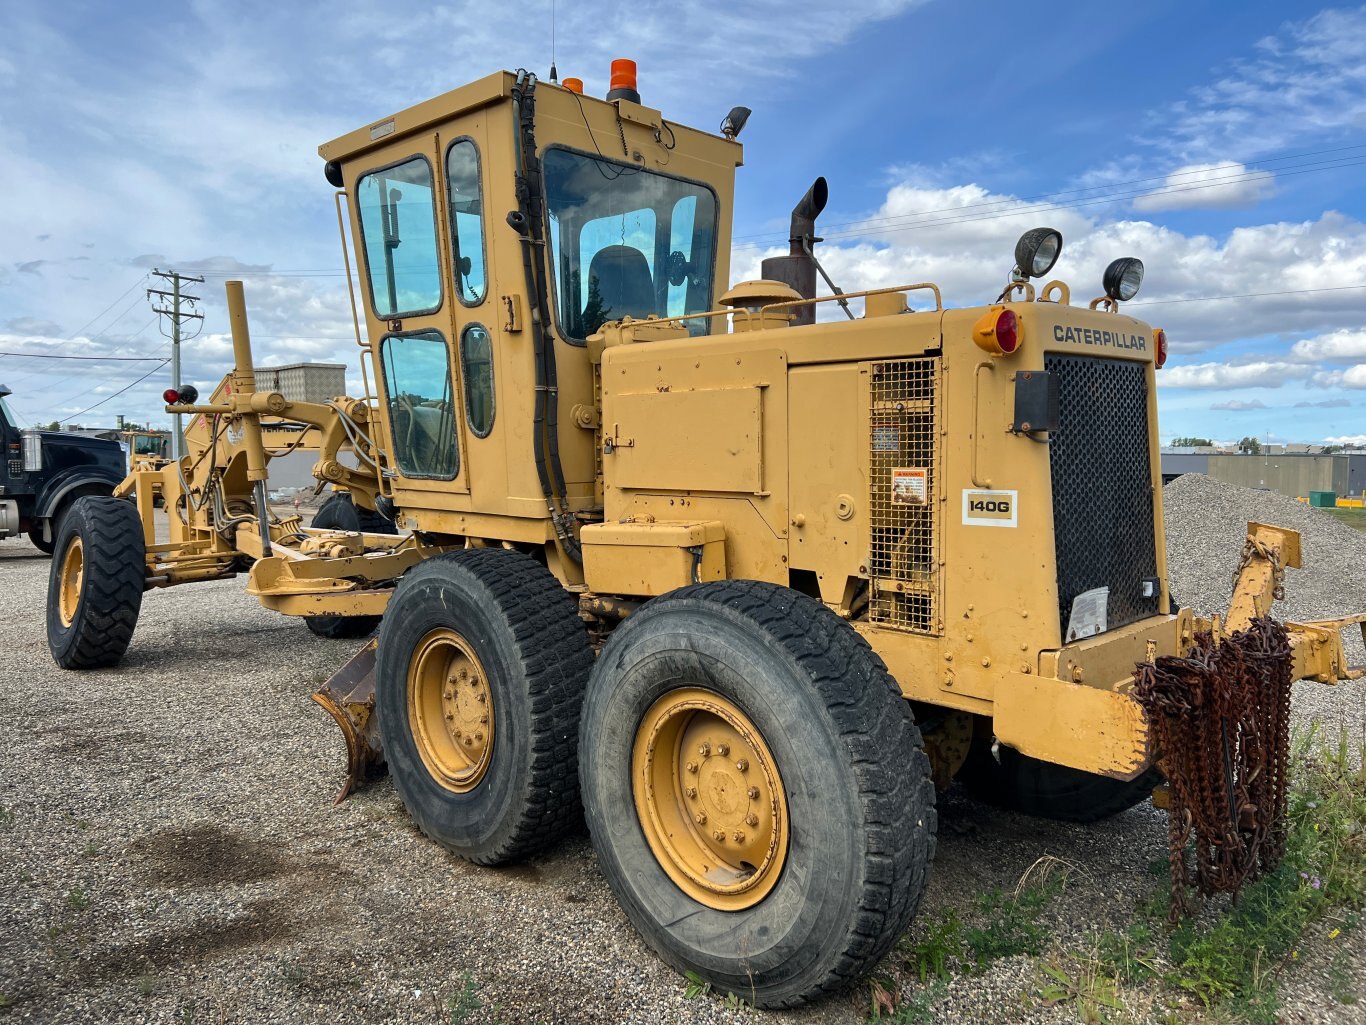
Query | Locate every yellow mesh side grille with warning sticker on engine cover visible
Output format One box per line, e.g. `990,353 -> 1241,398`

869,359 -> 940,633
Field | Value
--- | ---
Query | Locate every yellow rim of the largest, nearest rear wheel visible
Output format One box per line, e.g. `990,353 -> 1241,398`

631,687 -> 788,912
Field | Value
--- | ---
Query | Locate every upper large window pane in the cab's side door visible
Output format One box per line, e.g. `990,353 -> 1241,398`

355,157 -> 441,320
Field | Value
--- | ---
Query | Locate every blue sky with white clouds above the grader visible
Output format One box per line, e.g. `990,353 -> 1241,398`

0,0 -> 1366,443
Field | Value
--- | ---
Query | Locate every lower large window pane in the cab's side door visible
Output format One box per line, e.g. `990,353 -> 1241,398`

380,331 -> 460,480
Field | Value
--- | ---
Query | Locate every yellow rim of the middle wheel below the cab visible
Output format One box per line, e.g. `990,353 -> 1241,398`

408,629 -> 493,794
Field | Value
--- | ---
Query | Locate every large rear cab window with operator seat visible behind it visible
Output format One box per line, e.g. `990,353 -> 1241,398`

545,149 -> 716,342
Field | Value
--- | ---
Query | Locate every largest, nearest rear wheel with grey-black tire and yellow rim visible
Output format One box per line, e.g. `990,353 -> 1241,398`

579,581 -> 936,1007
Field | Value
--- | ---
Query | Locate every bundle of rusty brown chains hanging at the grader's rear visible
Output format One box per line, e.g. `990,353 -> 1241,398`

1134,618 -> 1291,923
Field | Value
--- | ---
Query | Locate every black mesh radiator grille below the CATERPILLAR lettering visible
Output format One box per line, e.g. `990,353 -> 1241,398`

1044,354 -> 1158,636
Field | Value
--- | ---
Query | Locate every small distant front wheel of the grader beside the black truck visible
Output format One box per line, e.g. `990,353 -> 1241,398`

48,497 -> 146,670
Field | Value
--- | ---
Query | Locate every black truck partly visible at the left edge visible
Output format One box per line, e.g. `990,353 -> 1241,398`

0,384 -> 127,555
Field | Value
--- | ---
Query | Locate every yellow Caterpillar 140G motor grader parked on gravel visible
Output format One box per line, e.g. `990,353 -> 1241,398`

48,62 -> 1363,1006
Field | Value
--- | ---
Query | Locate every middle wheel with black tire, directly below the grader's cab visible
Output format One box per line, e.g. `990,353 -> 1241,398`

376,548 -> 593,865
